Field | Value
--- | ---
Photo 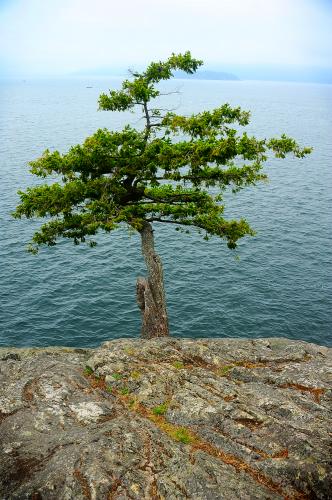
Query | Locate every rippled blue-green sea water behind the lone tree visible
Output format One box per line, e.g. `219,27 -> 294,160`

0,78 -> 332,346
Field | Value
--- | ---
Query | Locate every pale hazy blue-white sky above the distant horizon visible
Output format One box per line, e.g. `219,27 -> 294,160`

0,0 -> 332,76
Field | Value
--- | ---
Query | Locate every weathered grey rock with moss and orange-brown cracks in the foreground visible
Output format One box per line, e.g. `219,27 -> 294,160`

0,338 -> 332,500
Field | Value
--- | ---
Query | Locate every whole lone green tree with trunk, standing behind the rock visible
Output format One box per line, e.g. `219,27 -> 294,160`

13,52 -> 310,338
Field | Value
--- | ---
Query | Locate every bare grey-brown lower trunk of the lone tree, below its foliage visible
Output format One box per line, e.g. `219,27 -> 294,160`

136,222 -> 169,339
